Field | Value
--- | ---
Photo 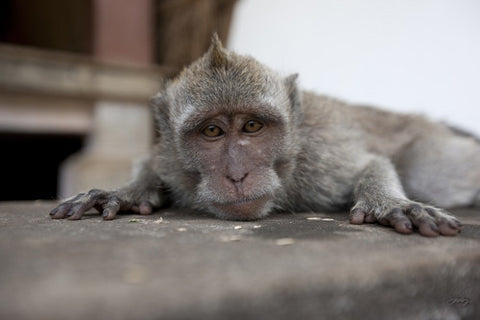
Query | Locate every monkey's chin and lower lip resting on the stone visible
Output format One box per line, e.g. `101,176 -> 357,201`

211,196 -> 272,220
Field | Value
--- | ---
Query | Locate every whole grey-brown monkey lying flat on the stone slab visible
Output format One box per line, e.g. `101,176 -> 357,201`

51,37 -> 480,236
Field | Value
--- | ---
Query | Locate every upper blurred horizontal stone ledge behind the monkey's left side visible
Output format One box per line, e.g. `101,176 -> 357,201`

0,44 -> 177,103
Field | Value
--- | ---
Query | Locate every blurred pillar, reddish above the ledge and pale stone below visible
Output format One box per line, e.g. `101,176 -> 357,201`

59,0 -> 155,197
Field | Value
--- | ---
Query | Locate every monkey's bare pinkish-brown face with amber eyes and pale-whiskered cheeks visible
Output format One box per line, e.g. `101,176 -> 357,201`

183,106 -> 284,220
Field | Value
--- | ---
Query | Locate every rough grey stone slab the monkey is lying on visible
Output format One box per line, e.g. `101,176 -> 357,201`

0,202 -> 480,319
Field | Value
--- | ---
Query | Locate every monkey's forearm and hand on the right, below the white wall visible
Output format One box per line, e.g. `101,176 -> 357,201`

350,157 -> 461,237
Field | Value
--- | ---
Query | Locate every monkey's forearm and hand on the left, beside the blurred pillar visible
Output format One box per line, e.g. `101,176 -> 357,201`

50,161 -> 165,220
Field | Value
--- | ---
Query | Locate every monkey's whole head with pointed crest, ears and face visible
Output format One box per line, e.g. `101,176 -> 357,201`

152,35 -> 301,220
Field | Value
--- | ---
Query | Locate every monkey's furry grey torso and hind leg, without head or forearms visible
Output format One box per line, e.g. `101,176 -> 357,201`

279,92 -> 480,211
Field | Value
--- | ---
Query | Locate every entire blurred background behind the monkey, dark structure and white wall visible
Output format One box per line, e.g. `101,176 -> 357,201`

0,0 -> 480,200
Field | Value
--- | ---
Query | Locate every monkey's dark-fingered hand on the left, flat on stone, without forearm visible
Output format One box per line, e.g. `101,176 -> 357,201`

50,189 -> 153,220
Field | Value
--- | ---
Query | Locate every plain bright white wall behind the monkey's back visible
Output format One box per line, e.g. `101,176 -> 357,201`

228,0 -> 480,135
